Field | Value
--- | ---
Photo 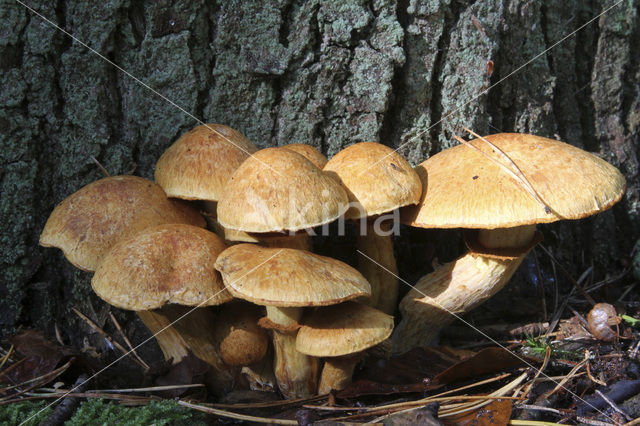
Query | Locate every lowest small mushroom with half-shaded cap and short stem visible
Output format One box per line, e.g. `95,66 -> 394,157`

296,302 -> 393,395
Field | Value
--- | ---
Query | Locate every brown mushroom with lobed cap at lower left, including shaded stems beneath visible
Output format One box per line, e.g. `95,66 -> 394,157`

91,224 -> 239,393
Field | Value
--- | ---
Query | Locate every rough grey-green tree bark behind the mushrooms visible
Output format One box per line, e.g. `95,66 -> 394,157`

0,0 -> 640,350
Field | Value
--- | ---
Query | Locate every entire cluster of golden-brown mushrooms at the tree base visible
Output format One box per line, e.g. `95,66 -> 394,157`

40,124 -> 624,398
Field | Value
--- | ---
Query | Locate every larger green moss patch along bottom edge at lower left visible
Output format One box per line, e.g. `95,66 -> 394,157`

65,399 -> 207,426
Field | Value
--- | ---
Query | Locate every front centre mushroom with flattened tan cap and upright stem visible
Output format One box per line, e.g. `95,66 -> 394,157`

216,244 -> 371,398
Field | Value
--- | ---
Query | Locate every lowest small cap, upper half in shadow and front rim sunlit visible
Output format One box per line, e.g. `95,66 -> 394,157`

296,302 -> 393,357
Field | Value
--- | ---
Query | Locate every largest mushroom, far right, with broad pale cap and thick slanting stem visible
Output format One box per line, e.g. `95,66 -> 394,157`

393,133 -> 625,353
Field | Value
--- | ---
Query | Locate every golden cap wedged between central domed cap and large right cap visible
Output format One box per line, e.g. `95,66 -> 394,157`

324,142 -> 422,219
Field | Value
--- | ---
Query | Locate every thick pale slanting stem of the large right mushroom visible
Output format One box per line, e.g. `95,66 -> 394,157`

392,225 -> 535,353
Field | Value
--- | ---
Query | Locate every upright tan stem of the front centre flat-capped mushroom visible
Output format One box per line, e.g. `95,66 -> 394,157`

267,306 -> 319,399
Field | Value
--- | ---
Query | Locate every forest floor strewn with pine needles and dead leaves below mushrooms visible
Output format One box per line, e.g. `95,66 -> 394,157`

0,241 -> 640,425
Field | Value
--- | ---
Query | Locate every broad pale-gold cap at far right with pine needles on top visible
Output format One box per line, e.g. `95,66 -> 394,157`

402,133 -> 625,229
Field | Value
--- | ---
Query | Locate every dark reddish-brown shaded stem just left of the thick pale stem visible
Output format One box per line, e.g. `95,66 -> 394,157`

356,219 -> 398,315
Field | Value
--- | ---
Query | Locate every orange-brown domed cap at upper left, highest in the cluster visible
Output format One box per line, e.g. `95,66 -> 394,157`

155,124 -> 258,201
